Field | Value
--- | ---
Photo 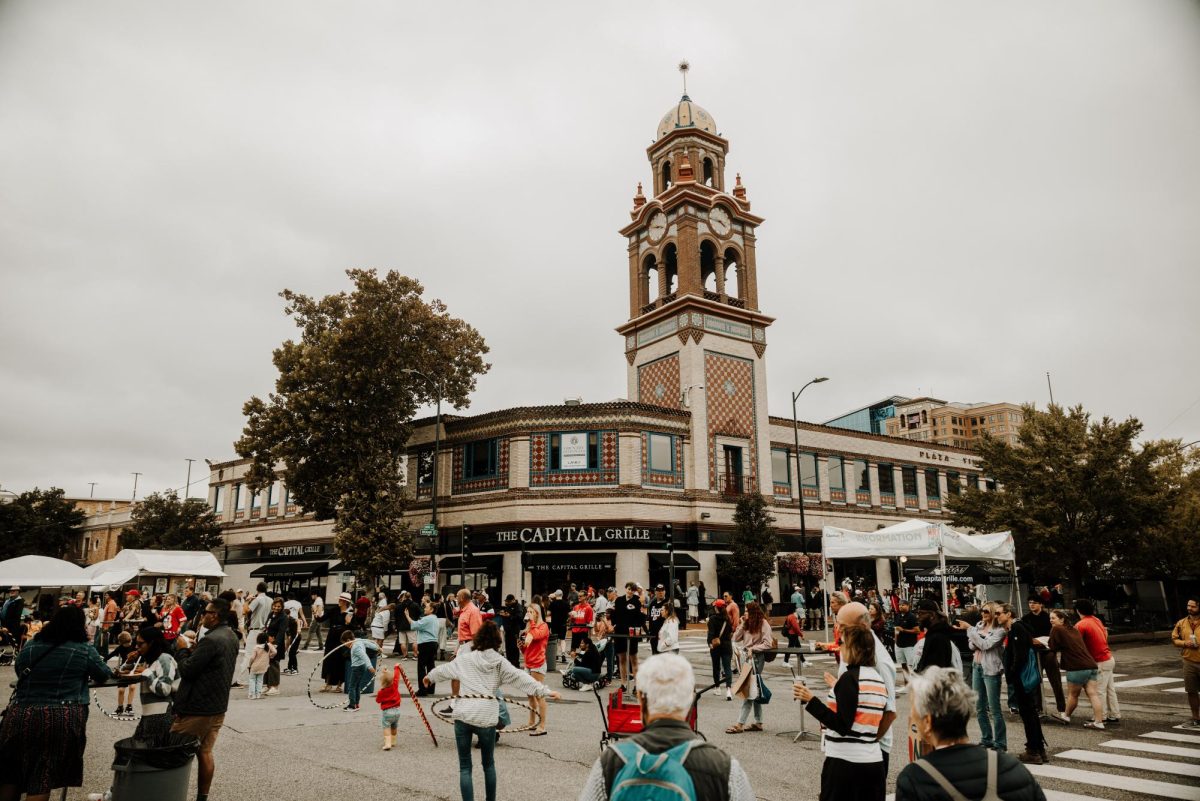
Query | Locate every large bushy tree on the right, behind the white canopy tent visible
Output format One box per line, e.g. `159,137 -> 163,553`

948,405 -> 1163,591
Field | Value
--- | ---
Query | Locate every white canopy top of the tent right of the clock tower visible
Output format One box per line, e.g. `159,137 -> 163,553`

822,519 -> 1016,562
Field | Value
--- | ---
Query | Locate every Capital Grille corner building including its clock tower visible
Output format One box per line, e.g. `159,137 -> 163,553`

210,95 -> 983,601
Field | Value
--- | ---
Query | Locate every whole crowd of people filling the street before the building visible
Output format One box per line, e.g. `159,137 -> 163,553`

0,582 -> 1200,801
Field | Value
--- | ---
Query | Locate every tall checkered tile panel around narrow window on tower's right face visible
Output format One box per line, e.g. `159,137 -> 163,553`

704,351 -> 758,492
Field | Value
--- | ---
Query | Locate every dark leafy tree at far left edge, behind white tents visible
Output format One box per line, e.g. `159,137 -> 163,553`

0,487 -> 88,560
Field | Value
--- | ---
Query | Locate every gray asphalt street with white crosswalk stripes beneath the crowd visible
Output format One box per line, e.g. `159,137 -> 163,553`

0,638 -> 1200,801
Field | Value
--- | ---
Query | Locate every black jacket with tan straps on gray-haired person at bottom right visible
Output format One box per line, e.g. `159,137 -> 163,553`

895,745 -> 1046,801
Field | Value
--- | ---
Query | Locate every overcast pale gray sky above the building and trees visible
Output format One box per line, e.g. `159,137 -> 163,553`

0,0 -> 1200,498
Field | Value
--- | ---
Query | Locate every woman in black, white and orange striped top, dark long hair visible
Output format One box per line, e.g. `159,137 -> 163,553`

792,626 -> 895,801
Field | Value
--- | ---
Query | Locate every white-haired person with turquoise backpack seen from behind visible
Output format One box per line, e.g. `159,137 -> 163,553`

580,654 -> 755,801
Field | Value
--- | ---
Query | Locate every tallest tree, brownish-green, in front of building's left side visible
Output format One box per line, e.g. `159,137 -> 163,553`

235,270 -> 490,585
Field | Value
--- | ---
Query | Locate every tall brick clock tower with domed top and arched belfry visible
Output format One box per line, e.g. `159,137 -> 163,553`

617,76 -> 774,496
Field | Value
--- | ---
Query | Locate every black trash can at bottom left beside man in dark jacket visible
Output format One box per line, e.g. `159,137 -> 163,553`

113,733 -> 200,801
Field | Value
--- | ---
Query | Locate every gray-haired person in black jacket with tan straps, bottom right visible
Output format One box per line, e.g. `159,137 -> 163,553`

895,667 -> 1045,801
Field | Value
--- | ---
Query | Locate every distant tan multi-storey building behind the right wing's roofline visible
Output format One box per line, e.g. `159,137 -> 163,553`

883,398 -> 1025,448
